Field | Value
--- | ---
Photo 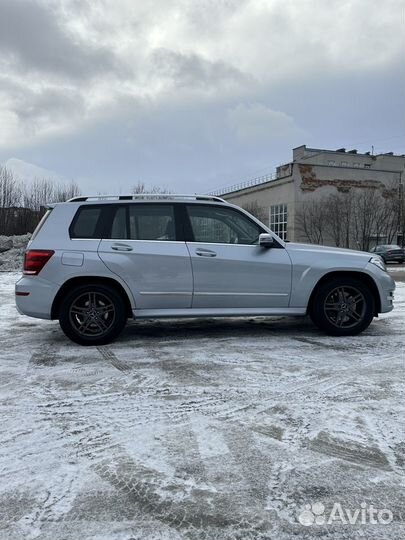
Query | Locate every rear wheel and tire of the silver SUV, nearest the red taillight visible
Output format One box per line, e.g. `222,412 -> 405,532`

59,284 -> 127,345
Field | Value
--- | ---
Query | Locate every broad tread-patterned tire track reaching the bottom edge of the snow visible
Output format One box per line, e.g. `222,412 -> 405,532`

93,452 -> 263,539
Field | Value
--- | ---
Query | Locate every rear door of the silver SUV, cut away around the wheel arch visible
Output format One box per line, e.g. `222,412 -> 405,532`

99,203 -> 193,309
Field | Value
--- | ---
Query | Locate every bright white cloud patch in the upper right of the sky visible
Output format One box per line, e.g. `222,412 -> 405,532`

186,0 -> 405,84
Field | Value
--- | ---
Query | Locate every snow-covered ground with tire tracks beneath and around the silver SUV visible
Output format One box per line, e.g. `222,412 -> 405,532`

0,273 -> 405,540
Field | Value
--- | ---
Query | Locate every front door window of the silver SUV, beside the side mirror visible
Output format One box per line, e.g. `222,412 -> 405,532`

187,205 -> 263,245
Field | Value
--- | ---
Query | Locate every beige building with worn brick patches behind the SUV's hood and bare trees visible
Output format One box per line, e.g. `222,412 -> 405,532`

215,145 -> 405,247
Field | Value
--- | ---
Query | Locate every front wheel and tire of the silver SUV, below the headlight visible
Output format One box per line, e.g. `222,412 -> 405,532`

310,277 -> 375,336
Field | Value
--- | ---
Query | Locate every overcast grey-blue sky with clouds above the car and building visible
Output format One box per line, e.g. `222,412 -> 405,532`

0,0 -> 405,192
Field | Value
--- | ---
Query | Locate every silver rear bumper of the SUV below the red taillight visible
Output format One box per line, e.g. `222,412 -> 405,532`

15,276 -> 58,319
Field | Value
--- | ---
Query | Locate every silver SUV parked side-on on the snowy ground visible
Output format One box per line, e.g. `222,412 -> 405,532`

15,195 -> 395,345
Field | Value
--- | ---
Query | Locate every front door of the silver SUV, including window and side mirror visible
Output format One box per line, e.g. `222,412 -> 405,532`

184,204 -> 291,308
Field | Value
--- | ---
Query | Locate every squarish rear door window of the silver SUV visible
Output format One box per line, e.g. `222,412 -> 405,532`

129,204 -> 176,241
